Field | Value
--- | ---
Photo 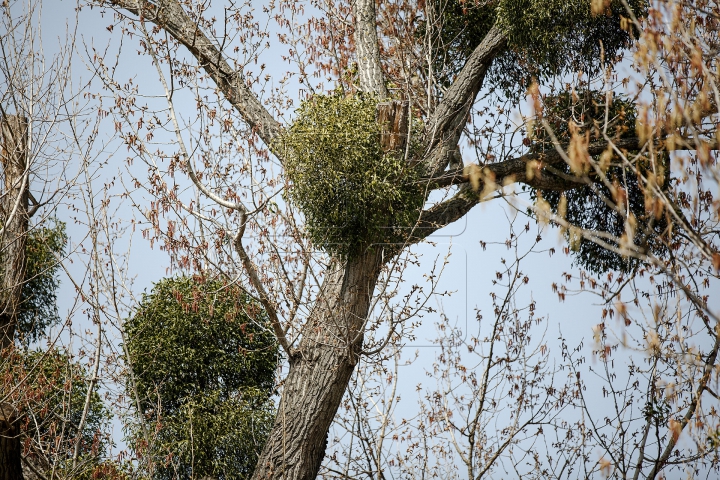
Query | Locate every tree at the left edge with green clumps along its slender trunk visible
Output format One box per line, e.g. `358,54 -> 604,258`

0,2 -> 112,479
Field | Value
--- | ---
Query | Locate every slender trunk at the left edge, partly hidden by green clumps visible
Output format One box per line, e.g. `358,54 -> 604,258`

0,115 -> 28,480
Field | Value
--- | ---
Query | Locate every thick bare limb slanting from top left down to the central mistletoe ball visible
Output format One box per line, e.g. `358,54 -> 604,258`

108,0 -> 282,148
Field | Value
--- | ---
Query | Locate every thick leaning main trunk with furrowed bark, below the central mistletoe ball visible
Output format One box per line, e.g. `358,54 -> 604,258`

253,247 -> 381,480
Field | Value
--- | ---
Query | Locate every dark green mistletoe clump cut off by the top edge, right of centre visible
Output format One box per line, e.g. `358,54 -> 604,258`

420,0 -> 647,97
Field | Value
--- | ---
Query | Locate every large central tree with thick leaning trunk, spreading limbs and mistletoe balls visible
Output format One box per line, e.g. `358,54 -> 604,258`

86,0 -> 720,479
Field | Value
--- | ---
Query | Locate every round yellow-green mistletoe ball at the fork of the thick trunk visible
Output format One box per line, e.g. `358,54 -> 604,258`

281,93 -> 424,257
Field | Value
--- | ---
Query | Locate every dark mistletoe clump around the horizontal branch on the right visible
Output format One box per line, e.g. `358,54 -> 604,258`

531,91 -> 668,273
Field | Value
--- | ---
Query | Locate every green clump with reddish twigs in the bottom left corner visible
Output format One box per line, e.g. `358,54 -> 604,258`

0,349 -> 111,479
